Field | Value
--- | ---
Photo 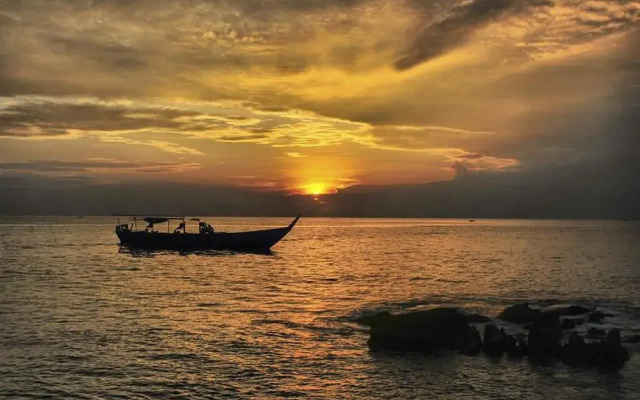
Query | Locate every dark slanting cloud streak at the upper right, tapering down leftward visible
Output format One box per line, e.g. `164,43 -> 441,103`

394,0 -> 553,70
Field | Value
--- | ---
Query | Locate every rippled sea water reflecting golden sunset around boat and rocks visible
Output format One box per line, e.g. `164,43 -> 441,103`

0,217 -> 640,399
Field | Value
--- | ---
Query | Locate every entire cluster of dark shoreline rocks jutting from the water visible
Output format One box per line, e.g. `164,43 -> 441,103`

358,303 -> 640,372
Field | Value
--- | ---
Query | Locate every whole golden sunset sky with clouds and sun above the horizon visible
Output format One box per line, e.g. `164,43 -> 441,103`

0,0 -> 640,218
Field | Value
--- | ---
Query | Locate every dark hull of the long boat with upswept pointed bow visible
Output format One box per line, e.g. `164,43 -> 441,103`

116,216 -> 300,252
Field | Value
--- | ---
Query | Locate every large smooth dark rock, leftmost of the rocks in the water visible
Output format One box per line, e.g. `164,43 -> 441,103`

367,308 -> 469,352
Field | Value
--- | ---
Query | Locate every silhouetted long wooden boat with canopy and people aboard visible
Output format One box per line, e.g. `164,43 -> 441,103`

116,214 -> 301,252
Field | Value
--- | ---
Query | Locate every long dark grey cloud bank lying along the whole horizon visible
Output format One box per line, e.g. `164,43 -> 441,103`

0,165 -> 640,219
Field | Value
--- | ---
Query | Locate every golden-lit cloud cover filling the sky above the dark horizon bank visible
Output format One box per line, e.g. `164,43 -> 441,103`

0,0 -> 640,202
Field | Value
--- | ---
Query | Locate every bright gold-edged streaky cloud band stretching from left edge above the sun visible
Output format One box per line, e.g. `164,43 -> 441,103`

0,96 -> 370,150
